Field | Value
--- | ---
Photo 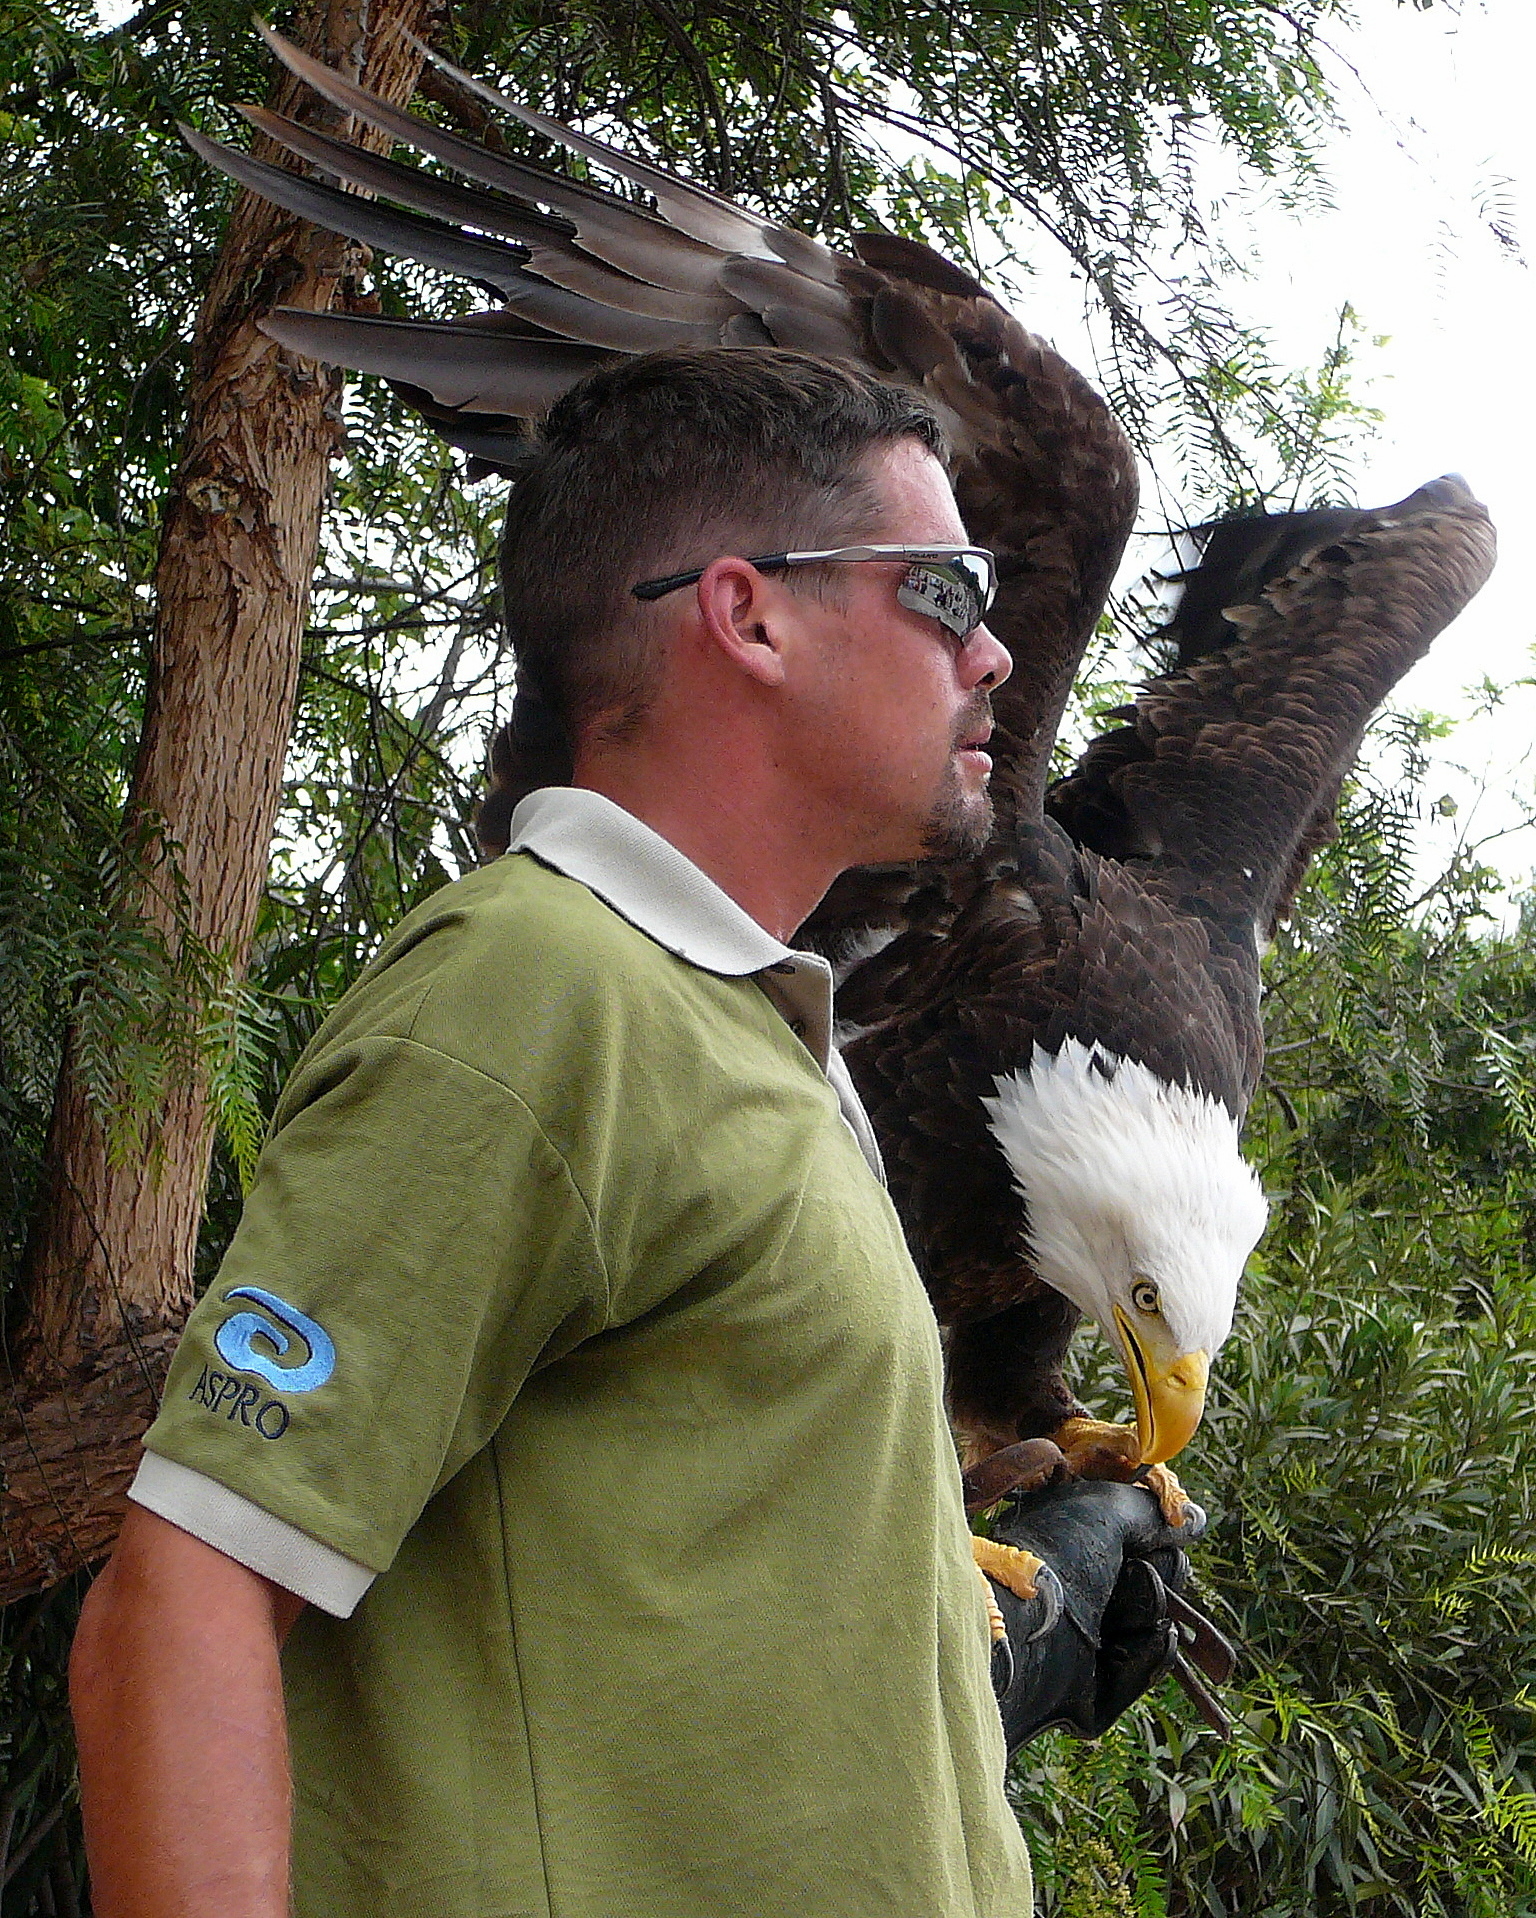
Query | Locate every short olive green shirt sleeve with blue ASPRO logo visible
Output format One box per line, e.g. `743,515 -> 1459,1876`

134,1036 -> 610,1609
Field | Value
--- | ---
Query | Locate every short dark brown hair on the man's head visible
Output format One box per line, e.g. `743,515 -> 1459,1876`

500,347 -> 947,731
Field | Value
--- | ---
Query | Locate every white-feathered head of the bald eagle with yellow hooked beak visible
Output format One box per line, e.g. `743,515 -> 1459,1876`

986,1040 -> 1269,1463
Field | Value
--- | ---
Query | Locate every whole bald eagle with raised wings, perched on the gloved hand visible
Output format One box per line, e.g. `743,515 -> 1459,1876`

184,29 -> 1494,1517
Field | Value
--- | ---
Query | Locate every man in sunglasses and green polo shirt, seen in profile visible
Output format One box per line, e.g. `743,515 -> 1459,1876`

73,349 -> 1168,1918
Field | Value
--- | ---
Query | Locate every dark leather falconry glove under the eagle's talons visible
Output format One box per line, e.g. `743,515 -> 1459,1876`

991,1479 -> 1206,1757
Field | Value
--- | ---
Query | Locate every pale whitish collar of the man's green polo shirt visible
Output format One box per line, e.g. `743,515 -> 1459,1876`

508,786 -> 884,1181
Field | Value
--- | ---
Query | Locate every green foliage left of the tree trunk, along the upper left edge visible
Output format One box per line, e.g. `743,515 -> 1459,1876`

0,4 -> 217,1289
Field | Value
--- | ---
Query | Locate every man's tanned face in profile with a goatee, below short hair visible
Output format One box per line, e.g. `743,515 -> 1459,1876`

796,441 -> 1012,865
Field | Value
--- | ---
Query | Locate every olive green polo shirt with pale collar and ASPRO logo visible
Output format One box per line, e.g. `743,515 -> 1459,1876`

134,790 -> 1030,1918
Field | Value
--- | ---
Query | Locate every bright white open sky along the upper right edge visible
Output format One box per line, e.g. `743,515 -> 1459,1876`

1135,0 -> 1536,886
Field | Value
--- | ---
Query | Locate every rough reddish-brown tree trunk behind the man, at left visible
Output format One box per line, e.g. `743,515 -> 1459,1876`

0,0 -> 435,1603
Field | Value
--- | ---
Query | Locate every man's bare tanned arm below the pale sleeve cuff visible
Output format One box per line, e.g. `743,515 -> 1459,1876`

69,1506 -> 303,1918
